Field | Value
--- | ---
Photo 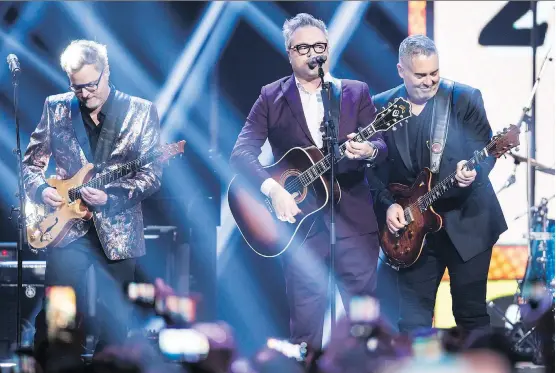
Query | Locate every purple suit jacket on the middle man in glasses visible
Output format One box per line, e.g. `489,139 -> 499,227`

230,75 -> 388,238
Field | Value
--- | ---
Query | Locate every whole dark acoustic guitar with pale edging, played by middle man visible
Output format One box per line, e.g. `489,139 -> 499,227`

228,97 -> 412,257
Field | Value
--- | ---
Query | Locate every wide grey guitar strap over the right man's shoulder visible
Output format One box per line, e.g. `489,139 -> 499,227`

430,79 -> 454,173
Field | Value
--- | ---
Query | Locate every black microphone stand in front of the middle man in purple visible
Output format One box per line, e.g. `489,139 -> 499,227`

318,61 -> 341,335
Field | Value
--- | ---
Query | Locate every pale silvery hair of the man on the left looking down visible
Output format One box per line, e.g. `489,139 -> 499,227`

60,40 -> 108,74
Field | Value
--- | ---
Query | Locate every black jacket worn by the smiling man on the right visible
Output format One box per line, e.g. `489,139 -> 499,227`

367,83 -> 508,261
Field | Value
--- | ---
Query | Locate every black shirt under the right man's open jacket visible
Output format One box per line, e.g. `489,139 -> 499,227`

407,100 -> 434,176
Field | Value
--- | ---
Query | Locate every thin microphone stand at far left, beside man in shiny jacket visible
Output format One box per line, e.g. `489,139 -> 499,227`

10,61 -> 26,348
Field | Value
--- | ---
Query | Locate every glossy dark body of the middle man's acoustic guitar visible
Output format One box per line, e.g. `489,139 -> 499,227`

228,147 -> 341,257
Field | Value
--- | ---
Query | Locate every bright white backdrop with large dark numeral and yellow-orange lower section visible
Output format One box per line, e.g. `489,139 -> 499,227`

434,1 -> 556,327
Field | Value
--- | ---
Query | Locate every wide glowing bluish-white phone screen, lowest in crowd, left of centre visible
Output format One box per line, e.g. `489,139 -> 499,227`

158,329 -> 210,363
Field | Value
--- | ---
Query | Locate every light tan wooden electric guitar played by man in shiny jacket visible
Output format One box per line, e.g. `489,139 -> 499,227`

26,140 -> 185,249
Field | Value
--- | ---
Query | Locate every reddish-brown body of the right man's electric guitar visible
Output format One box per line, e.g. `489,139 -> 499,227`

380,168 -> 442,268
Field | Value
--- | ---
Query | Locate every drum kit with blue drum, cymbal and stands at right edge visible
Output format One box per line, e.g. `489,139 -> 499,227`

487,42 -> 555,363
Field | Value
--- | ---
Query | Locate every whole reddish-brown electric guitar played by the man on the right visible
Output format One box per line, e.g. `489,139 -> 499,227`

380,125 -> 520,268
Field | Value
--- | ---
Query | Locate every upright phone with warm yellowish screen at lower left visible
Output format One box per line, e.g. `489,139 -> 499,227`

45,286 -> 77,340
